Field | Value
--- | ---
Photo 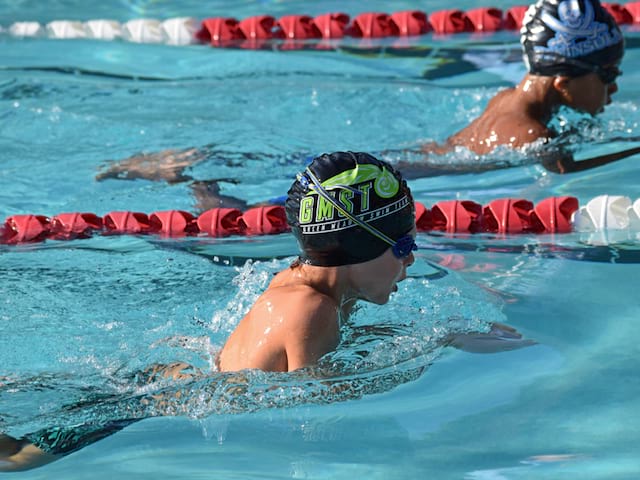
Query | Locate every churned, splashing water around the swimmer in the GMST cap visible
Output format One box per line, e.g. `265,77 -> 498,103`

0,260 -> 504,442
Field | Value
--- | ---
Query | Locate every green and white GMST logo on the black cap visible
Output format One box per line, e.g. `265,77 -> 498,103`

298,164 -> 409,234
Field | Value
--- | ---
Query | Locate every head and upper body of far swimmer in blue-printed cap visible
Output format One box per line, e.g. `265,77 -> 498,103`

398,0 -> 640,177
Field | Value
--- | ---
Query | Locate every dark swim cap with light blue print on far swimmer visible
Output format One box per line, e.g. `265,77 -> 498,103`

520,0 -> 624,77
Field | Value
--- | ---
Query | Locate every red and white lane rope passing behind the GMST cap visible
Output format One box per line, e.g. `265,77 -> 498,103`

0,195 -> 640,245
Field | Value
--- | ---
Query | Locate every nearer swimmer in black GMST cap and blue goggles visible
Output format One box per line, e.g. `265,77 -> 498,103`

0,152 -> 533,471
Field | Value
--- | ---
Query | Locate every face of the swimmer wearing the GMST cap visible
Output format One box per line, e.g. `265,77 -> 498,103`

349,227 -> 416,305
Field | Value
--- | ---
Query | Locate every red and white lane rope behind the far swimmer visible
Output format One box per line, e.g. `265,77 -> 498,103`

5,1 -> 640,50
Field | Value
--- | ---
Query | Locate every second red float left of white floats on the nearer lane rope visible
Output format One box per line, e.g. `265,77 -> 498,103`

483,198 -> 534,233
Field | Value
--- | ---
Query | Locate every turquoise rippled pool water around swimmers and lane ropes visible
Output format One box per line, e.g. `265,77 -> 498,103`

0,1 -> 640,479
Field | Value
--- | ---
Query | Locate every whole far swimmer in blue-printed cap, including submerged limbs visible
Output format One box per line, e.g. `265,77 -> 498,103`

96,0 -> 640,192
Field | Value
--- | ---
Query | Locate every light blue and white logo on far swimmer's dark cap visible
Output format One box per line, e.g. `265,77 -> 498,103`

527,0 -> 622,58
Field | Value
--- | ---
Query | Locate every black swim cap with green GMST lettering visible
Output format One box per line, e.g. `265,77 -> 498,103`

285,152 -> 415,267
